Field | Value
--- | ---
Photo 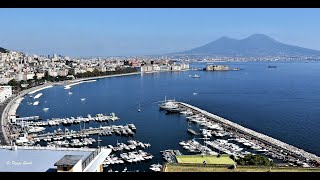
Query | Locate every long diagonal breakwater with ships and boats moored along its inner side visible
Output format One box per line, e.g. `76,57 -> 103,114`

160,101 -> 320,167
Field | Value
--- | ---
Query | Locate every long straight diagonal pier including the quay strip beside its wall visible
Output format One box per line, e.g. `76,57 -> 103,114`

176,102 -> 320,163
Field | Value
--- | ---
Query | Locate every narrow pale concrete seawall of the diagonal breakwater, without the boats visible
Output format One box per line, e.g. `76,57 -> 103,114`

178,102 -> 320,162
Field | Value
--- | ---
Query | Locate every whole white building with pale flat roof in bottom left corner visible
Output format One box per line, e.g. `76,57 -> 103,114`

0,146 -> 112,172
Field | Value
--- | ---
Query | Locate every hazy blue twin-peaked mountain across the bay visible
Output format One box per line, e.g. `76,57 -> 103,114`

173,34 -> 320,57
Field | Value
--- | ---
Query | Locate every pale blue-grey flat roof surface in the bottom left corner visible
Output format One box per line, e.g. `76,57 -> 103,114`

0,146 -> 95,172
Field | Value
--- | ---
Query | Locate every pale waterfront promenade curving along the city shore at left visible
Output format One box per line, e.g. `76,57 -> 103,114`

0,72 -> 141,145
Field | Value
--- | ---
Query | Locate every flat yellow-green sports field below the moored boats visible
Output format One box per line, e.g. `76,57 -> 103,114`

176,155 -> 235,165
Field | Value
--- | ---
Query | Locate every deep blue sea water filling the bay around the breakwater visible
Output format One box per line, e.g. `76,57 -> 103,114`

17,62 -> 320,171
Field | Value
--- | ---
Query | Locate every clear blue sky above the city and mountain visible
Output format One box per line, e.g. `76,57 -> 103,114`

0,8 -> 320,56
